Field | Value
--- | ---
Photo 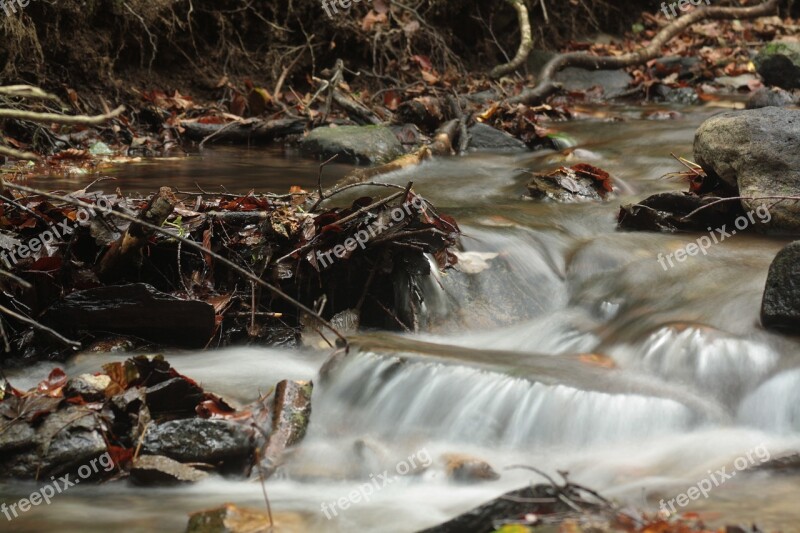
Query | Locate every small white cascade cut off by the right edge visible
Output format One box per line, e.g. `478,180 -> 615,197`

738,369 -> 800,434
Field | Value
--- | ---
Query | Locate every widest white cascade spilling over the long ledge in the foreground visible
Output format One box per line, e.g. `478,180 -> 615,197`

312,353 -> 709,449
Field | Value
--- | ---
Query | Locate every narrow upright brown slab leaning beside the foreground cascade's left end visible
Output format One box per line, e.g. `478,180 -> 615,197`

261,380 -> 314,474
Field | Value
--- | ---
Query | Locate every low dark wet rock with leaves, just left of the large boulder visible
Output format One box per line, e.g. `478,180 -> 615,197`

617,192 -> 743,232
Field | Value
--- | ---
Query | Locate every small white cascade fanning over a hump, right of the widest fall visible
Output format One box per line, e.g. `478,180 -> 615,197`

611,324 -> 780,404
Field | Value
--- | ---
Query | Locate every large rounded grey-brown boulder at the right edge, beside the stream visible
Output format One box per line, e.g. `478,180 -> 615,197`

694,107 -> 800,233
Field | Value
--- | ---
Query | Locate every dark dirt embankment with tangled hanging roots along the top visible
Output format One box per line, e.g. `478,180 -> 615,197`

0,0 -> 651,107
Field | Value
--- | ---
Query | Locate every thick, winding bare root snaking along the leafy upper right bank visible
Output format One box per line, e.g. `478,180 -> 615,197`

507,0 -> 778,105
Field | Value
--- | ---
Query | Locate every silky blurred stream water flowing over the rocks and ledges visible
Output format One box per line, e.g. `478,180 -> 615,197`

0,102 -> 800,532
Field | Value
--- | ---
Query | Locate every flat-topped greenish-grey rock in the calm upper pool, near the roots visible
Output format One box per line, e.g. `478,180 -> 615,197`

300,126 -> 404,165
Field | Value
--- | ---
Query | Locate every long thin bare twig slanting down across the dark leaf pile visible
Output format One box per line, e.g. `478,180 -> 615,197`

0,180 -> 349,347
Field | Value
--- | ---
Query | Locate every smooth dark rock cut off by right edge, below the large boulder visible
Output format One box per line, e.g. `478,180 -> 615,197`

761,241 -> 800,330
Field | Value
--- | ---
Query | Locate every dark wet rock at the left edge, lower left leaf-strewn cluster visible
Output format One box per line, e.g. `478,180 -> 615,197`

0,406 -> 106,479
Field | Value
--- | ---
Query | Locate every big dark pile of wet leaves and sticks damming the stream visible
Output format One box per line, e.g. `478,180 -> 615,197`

0,180 -> 459,360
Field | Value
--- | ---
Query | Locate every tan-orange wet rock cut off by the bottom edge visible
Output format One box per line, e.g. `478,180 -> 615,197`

186,503 -> 313,533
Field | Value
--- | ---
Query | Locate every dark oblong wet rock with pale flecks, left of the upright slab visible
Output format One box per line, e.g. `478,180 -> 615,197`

142,418 -> 253,464
